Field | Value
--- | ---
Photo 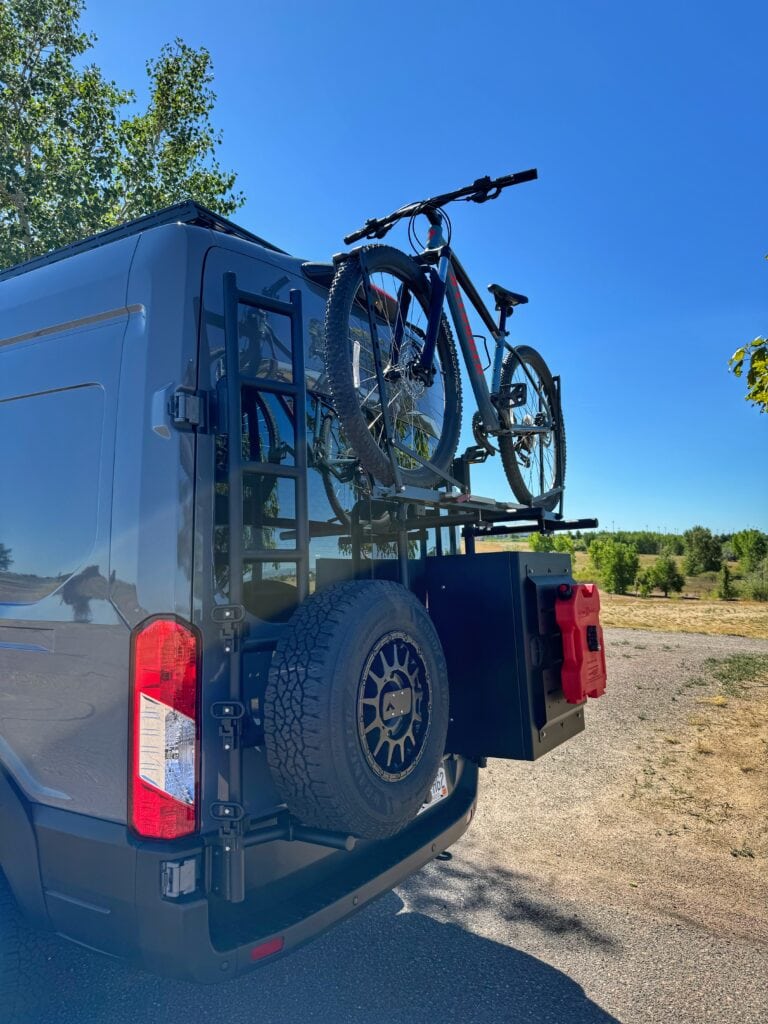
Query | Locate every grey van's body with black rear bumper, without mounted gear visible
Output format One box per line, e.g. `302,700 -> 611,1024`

0,214 -> 487,981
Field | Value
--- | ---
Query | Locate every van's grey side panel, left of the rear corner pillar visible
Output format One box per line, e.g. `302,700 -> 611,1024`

0,299 -> 130,821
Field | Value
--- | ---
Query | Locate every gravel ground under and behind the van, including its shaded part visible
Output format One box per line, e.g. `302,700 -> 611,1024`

7,630 -> 768,1024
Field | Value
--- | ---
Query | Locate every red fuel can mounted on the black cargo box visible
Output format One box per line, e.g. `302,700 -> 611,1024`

555,583 -> 606,703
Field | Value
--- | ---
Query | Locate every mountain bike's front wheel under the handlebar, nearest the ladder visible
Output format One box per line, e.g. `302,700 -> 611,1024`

325,246 -> 461,487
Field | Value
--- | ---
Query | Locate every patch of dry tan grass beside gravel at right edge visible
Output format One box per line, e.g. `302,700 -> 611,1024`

635,654 -> 768,865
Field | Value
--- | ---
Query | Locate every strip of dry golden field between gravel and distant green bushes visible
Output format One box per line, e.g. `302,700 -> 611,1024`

600,592 -> 768,640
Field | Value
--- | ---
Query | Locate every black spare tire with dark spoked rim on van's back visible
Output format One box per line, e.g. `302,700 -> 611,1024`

264,580 -> 449,839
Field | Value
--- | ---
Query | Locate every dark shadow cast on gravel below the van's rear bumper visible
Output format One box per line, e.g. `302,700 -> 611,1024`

15,863 -> 618,1024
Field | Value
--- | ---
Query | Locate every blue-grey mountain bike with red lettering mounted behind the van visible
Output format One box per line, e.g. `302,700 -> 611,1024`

324,170 -> 565,511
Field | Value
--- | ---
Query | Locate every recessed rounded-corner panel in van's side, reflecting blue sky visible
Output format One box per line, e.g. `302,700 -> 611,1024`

0,385 -> 103,604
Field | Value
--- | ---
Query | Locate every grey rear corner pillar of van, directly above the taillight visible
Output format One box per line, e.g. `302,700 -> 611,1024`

111,225 -> 210,628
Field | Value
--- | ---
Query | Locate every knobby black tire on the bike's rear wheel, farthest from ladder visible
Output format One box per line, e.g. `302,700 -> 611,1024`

499,345 -> 565,512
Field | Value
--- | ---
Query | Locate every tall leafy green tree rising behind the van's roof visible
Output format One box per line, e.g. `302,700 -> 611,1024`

0,0 -> 243,267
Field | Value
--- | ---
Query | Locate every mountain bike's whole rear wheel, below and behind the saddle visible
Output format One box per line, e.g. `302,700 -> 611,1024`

499,345 -> 565,512
